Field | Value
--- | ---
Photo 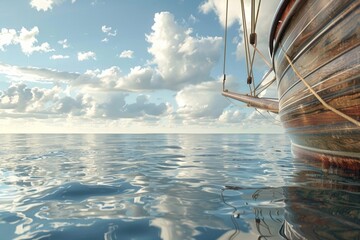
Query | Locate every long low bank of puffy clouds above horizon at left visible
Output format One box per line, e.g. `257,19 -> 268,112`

0,83 -> 170,119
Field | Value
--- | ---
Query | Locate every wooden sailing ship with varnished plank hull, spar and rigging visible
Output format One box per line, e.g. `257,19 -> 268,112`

222,0 -> 360,170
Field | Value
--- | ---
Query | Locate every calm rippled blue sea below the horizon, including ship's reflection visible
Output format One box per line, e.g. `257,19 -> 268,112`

0,134 -> 360,240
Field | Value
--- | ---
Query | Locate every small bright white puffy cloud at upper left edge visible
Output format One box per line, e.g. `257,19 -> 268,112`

0,27 -> 54,56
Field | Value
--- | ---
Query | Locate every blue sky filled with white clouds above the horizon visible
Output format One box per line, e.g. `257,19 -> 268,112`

0,0 -> 282,133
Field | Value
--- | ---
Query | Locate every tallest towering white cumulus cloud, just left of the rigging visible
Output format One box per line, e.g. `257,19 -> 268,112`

147,12 -> 222,90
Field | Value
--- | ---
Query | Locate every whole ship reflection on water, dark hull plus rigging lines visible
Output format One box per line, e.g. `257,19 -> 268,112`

220,159 -> 360,240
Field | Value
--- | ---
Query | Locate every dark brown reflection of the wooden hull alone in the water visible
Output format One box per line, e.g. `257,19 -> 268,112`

284,159 -> 360,240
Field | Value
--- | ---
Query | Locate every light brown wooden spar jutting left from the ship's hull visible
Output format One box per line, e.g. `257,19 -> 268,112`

222,91 -> 279,113
